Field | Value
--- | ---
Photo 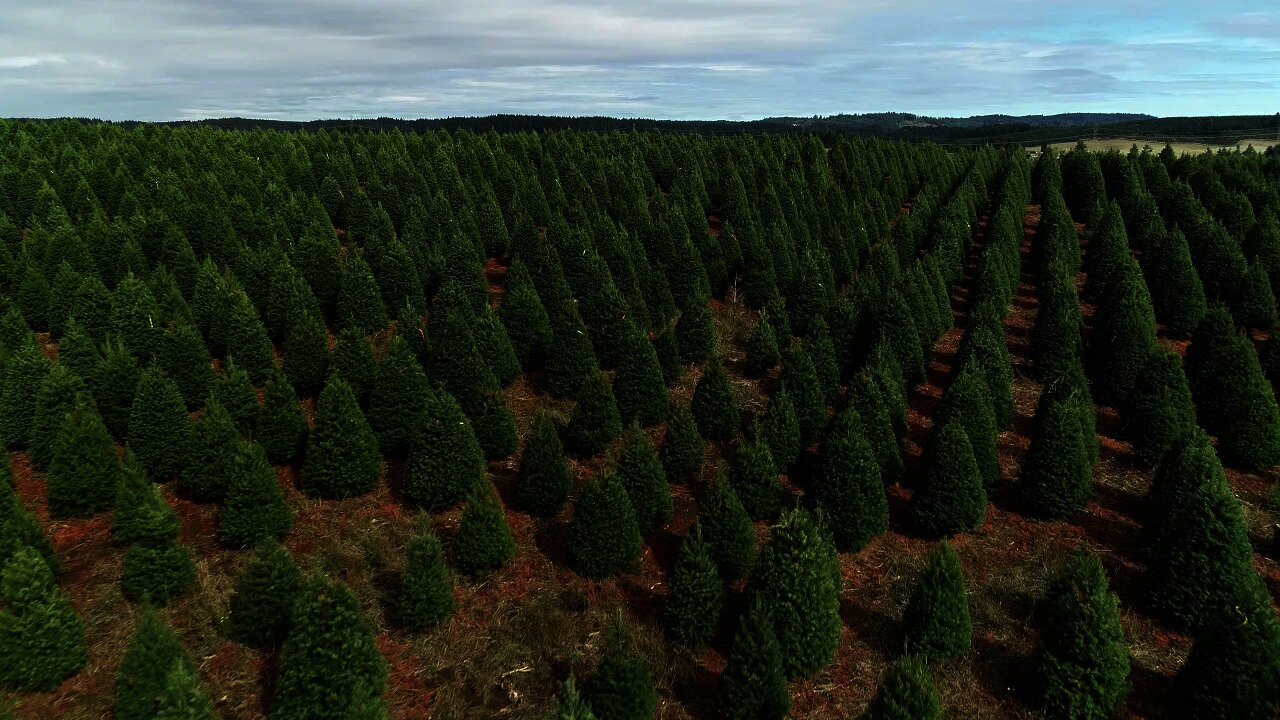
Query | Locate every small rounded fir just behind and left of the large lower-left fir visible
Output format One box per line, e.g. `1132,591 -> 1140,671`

230,541 -> 302,647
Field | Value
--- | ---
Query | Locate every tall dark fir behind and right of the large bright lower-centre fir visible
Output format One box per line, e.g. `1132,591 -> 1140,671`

812,409 -> 888,552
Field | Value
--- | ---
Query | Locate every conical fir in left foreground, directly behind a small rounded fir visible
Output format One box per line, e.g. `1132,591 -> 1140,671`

218,442 -> 293,548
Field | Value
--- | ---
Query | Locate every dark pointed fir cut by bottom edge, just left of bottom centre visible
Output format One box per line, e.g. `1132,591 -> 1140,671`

584,612 -> 658,720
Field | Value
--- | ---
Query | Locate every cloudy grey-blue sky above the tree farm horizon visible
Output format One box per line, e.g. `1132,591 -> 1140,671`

0,0 -> 1280,120
